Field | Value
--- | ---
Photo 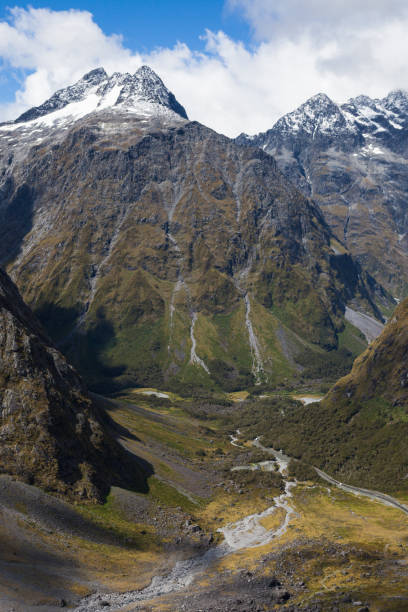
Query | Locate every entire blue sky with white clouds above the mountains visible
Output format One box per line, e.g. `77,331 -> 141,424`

0,0 -> 408,136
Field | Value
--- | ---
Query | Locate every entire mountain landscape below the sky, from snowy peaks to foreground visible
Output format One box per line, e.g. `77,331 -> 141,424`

0,66 -> 408,612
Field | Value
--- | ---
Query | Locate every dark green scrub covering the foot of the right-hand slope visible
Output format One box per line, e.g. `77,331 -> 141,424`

214,395 -> 408,494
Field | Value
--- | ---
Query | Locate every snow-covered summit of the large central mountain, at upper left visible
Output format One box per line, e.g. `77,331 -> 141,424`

14,66 -> 187,124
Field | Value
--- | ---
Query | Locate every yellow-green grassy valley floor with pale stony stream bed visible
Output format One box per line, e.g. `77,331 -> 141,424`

0,390 -> 408,612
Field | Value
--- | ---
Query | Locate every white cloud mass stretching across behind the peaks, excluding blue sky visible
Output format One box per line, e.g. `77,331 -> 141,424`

0,0 -> 408,135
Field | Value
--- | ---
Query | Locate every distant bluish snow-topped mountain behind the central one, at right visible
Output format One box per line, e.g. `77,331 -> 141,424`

238,91 -> 408,297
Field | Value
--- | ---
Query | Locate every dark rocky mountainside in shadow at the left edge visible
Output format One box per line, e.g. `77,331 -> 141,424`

0,270 -> 143,501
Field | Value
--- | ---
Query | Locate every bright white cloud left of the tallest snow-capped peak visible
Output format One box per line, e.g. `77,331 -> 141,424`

0,8 -> 142,117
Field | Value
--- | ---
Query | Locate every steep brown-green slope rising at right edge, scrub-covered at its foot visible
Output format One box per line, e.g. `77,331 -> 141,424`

267,299 -> 408,495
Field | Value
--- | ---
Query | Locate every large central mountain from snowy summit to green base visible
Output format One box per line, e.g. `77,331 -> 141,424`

0,67 -> 387,390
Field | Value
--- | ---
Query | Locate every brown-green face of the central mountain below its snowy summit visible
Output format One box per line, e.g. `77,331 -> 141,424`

9,121 -> 382,391
